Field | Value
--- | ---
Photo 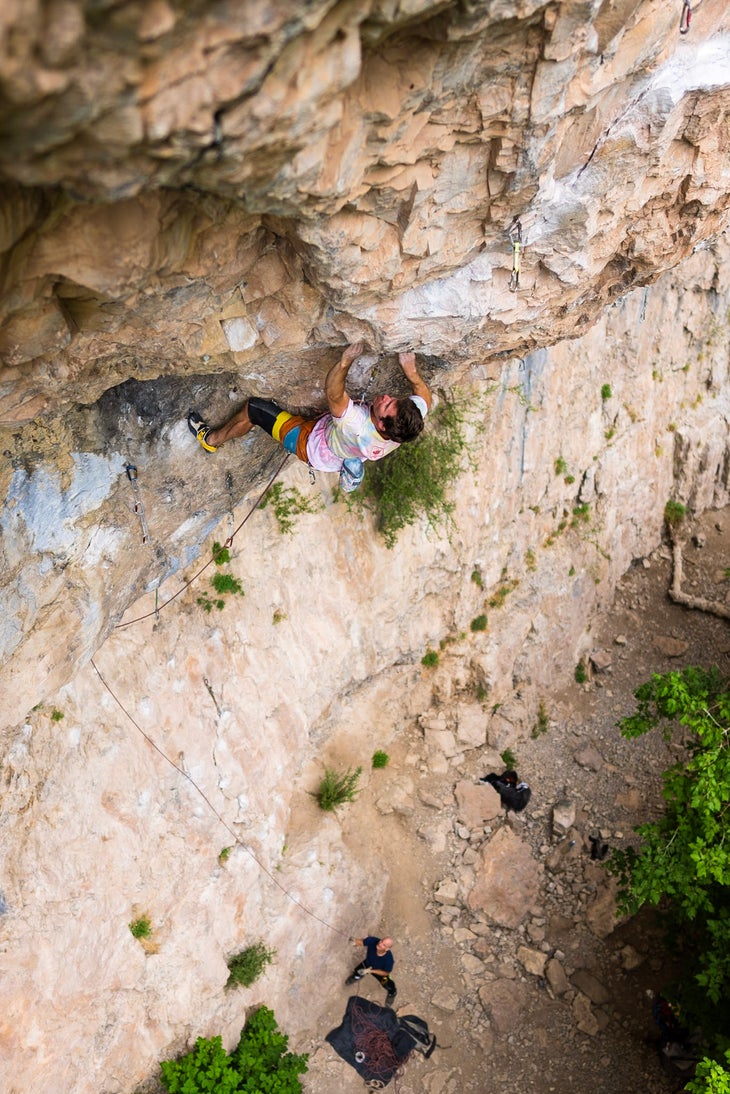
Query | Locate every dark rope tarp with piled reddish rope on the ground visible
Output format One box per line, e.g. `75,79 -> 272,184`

325,996 -> 414,1087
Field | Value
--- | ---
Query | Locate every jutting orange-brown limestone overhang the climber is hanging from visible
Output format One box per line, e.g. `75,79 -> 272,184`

0,0 -> 730,723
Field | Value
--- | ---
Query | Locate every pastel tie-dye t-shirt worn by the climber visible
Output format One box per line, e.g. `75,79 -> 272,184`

306,395 -> 428,472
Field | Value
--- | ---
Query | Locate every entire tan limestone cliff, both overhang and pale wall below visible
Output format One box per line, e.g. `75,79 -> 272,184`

0,0 -> 730,1094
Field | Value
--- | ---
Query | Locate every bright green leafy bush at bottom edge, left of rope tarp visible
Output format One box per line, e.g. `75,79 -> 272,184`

160,1006 -> 309,1094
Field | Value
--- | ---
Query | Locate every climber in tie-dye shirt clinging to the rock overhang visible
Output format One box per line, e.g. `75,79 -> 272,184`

187,342 -> 431,492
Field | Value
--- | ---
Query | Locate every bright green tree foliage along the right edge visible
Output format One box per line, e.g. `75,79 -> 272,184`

611,667 -> 730,1094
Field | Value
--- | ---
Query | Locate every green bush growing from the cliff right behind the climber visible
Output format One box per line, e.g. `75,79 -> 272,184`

346,396 -> 468,548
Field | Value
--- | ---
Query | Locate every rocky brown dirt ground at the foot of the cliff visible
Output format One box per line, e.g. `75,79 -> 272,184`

298,511 -> 730,1094
